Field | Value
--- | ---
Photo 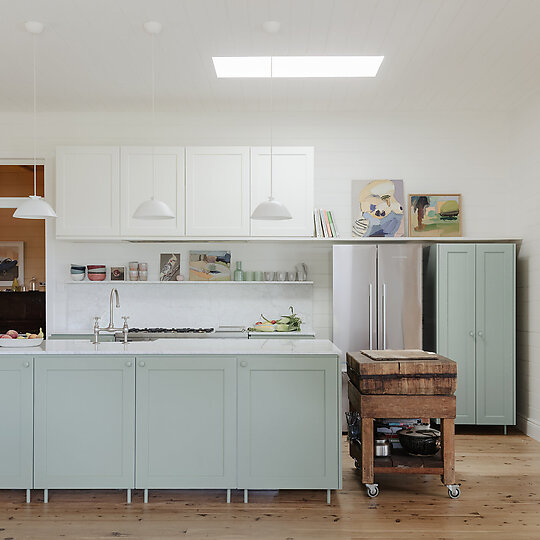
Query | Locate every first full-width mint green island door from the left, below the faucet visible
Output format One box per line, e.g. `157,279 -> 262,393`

34,355 -> 135,489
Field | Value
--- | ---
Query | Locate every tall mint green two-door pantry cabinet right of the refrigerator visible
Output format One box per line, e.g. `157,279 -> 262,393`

425,243 -> 516,427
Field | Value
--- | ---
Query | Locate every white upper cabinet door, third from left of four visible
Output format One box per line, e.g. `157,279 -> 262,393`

186,146 -> 250,237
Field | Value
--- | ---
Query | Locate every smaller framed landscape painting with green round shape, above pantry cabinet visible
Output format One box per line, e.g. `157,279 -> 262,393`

409,193 -> 462,237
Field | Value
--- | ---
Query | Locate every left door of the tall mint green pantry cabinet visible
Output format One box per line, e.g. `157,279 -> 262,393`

437,244 -> 476,424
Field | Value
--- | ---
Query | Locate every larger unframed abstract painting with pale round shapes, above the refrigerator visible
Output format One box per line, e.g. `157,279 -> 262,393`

351,180 -> 405,238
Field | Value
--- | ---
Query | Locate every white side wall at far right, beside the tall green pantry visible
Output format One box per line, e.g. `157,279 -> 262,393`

506,97 -> 540,440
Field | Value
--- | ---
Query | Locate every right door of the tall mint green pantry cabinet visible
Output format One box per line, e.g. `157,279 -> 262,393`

476,244 -> 516,425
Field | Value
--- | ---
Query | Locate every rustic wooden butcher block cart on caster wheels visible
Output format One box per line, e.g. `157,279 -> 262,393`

347,350 -> 460,498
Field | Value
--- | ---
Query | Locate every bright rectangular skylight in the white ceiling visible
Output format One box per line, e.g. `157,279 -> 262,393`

212,56 -> 384,79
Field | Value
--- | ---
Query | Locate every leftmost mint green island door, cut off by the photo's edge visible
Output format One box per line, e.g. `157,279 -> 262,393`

0,355 -> 33,489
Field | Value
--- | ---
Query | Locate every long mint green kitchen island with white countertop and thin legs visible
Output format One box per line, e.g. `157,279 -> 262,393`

0,339 -> 341,502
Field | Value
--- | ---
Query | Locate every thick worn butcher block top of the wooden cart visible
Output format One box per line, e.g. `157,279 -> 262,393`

347,350 -> 457,395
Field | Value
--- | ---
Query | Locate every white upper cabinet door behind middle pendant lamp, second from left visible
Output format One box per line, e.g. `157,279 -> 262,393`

120,146 -> 185,238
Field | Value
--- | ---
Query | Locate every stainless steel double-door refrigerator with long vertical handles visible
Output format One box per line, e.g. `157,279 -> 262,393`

333,244 -> 422,353
